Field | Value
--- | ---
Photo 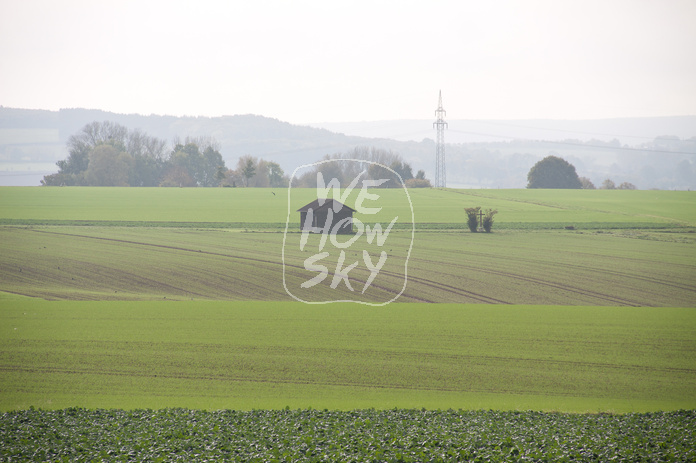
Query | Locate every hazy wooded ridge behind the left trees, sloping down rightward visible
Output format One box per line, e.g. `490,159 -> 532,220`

0,107 -> 378,185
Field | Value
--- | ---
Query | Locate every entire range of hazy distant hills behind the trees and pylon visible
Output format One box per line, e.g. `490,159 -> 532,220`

0,107 -> 696,189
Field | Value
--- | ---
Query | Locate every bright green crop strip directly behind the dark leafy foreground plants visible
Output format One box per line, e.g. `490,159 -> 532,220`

0,299 -> 696,412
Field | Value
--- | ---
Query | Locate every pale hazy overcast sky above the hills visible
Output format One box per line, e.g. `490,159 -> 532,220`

0,0 -> 696,123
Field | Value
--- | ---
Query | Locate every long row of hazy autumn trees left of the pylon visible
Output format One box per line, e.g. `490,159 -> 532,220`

41,121 -> 430,188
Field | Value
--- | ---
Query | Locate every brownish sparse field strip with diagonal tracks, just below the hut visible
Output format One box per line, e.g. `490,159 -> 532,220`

0,227 -> 696,307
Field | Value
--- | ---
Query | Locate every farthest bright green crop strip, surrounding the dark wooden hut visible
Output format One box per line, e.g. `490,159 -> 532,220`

0,187 -> 696,228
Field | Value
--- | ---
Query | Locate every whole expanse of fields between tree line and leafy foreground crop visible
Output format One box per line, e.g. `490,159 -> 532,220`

0,188 -> 696,412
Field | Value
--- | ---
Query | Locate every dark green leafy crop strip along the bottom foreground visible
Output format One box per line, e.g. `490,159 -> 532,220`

0,408 -> 696,462
